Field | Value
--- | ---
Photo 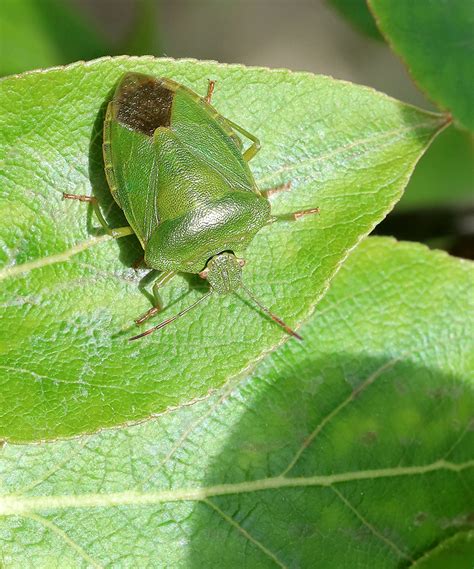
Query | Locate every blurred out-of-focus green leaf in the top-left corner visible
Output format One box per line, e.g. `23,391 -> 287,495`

0,0 -> 107,75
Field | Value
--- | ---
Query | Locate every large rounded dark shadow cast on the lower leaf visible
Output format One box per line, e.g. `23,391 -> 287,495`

189,346 -> 474,569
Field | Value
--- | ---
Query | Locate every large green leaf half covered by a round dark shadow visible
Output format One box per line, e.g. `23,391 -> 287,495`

0,238 -> 474,569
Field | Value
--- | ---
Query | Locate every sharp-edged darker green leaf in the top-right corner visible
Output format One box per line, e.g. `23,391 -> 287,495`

368,0 -> 474,131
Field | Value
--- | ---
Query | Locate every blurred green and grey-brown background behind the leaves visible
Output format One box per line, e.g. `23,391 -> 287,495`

0,0 -> 474,258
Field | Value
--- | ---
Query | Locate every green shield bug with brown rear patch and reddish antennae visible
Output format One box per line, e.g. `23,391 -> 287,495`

64,73 -> 318,340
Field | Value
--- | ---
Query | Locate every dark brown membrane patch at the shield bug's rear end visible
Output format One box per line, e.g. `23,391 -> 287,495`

114,73 -> 175,136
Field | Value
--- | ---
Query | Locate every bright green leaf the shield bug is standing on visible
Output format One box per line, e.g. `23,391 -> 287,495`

0,57 -> 445,441
